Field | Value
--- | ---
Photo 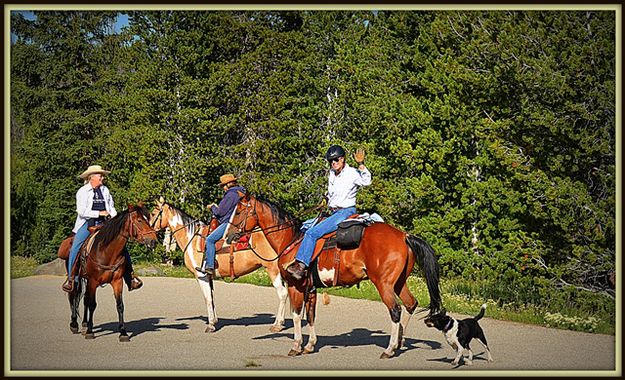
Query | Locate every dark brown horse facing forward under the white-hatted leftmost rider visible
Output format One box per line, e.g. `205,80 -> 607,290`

68,205 -> 158,342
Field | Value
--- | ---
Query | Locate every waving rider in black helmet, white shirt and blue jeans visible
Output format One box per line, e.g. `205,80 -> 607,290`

286,145 -> 371,280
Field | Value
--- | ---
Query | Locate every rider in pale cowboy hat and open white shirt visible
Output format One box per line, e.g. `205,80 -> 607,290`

62,165 -> 143,293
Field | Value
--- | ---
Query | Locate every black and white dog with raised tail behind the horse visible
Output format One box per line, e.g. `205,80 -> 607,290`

424,304 -> 493,365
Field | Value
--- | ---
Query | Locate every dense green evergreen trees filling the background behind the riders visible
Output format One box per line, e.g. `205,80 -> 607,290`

10,10 -> 616,300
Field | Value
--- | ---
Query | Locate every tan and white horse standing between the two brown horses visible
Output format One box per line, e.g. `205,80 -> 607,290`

150,197 -> 288,332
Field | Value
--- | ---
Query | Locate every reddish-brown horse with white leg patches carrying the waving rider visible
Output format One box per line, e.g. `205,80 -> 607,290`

229,193 -> 441,359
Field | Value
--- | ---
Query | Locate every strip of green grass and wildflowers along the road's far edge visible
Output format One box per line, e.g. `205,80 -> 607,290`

11,256 -> 616,335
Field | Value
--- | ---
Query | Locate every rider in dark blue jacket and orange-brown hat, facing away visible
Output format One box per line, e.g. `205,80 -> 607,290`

195,174 -> 245,276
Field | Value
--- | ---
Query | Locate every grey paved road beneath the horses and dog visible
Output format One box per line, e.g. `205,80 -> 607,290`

5,276 -> 621,376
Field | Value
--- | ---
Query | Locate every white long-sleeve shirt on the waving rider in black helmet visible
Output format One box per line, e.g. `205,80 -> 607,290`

328,163 -> 371,208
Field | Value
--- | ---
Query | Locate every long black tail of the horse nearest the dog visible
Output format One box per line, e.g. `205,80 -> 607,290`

406,235 -> 442,314
